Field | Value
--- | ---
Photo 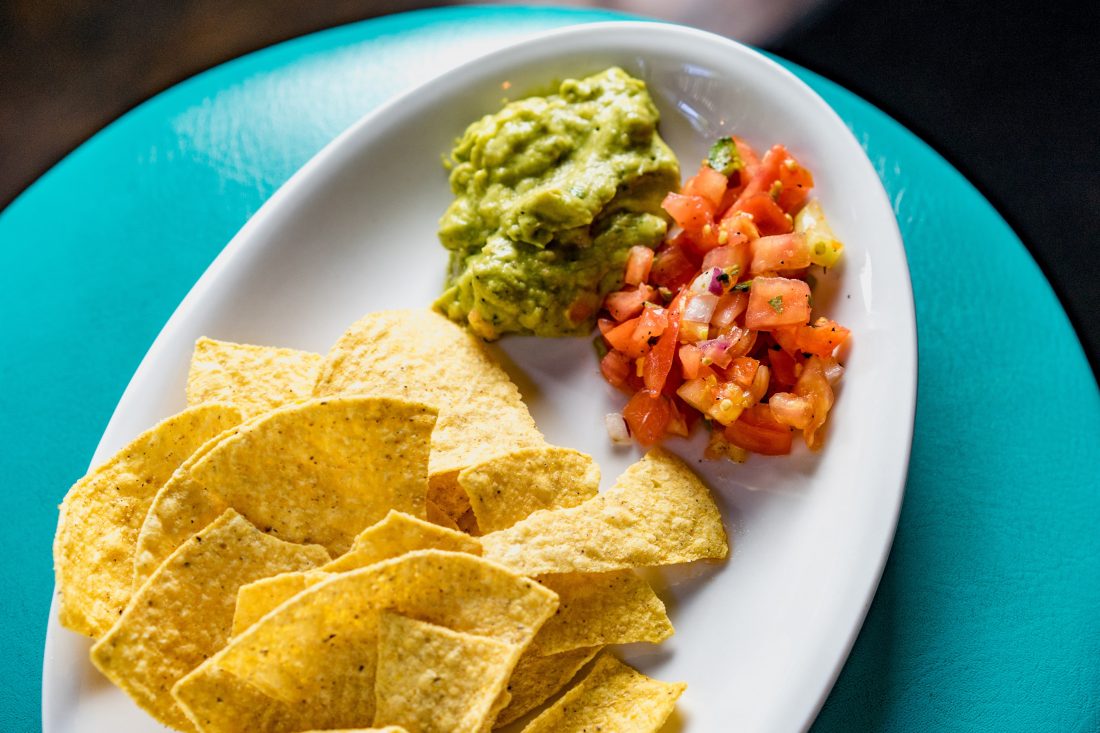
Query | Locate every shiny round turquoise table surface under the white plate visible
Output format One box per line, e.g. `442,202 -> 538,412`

0,8 -> 1100,732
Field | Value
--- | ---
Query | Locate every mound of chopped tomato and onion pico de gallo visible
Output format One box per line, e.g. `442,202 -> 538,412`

596,136 -> 849,461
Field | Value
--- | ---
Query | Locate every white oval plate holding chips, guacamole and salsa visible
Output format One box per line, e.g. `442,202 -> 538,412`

43,22 -> 916,733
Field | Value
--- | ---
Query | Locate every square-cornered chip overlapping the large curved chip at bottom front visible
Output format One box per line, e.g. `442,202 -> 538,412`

374,611 -> 519,733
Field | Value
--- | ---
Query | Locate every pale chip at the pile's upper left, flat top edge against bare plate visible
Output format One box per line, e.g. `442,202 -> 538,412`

187,337 -> 322,417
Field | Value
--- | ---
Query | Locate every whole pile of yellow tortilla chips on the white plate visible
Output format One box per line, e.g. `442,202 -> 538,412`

54,310 -> 728,733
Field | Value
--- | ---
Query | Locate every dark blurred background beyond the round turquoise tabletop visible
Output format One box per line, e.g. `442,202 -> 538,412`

0,0 -> 1100,373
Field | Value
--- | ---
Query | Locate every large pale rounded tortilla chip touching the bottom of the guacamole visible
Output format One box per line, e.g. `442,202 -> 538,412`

314,309 -> 545,477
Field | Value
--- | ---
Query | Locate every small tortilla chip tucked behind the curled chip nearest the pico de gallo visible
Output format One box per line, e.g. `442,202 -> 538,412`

458,446 -> 600,533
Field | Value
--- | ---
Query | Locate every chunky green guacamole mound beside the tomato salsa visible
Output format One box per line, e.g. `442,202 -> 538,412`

436,68 -> 680,339
